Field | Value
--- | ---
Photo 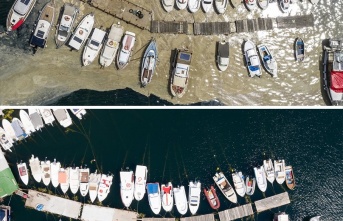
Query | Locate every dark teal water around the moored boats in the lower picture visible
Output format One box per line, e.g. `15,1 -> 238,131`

1,110 -> 343,221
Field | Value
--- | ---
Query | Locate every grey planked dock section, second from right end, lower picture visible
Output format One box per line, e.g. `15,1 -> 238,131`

219,203 -> 254,221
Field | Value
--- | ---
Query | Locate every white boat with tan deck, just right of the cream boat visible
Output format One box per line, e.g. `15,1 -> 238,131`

117,31 -> 136,69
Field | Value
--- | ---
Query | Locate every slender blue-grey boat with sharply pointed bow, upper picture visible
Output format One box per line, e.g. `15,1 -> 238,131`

141,39 -> 157,87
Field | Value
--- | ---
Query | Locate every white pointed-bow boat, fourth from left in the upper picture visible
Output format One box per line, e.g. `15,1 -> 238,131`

68,13 -> 94,51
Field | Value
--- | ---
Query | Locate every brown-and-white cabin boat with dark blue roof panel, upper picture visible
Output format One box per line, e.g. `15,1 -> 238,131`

170,49 -> 192,98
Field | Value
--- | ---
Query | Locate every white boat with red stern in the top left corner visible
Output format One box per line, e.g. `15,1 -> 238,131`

6,0 -> 36,31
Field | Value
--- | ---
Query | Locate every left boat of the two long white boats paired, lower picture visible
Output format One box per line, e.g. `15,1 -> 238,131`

120,170 -> 134,208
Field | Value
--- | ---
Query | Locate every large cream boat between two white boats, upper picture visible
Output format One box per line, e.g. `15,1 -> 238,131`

100,22 -> 124,67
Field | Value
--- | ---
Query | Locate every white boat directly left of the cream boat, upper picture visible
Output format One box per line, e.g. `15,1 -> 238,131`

82,28 -> 106,66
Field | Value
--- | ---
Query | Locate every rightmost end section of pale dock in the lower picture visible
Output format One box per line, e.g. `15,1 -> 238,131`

255,192 -> 291,212
